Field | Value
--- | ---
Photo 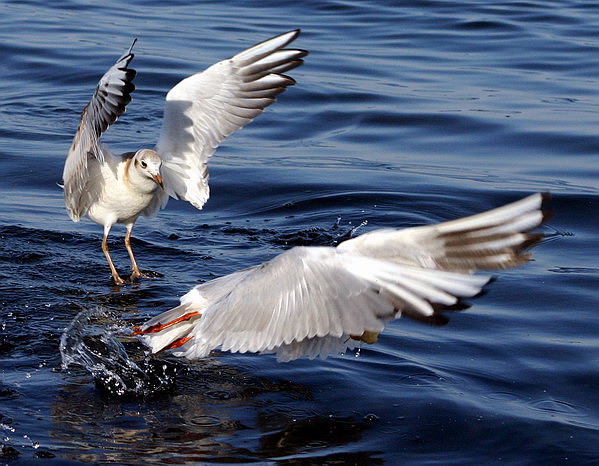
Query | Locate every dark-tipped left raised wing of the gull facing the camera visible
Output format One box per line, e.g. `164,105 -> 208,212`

62,41 -> 135,221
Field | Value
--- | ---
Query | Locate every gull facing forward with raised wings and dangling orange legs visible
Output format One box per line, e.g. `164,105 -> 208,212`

63,30 -> 307,284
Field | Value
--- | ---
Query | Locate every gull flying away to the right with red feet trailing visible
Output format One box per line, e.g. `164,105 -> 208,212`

133,194 -> 547,361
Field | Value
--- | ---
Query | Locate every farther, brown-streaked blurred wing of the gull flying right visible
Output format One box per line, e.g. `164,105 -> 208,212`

339,194 -> 549,272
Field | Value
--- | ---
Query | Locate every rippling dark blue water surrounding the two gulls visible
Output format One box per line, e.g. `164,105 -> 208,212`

0,0 -> 599,464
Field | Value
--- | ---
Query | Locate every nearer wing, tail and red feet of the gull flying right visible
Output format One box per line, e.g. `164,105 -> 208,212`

138,247 -> 489,360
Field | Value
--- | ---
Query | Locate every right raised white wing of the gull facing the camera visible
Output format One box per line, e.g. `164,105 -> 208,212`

156,30 -> 307,209
